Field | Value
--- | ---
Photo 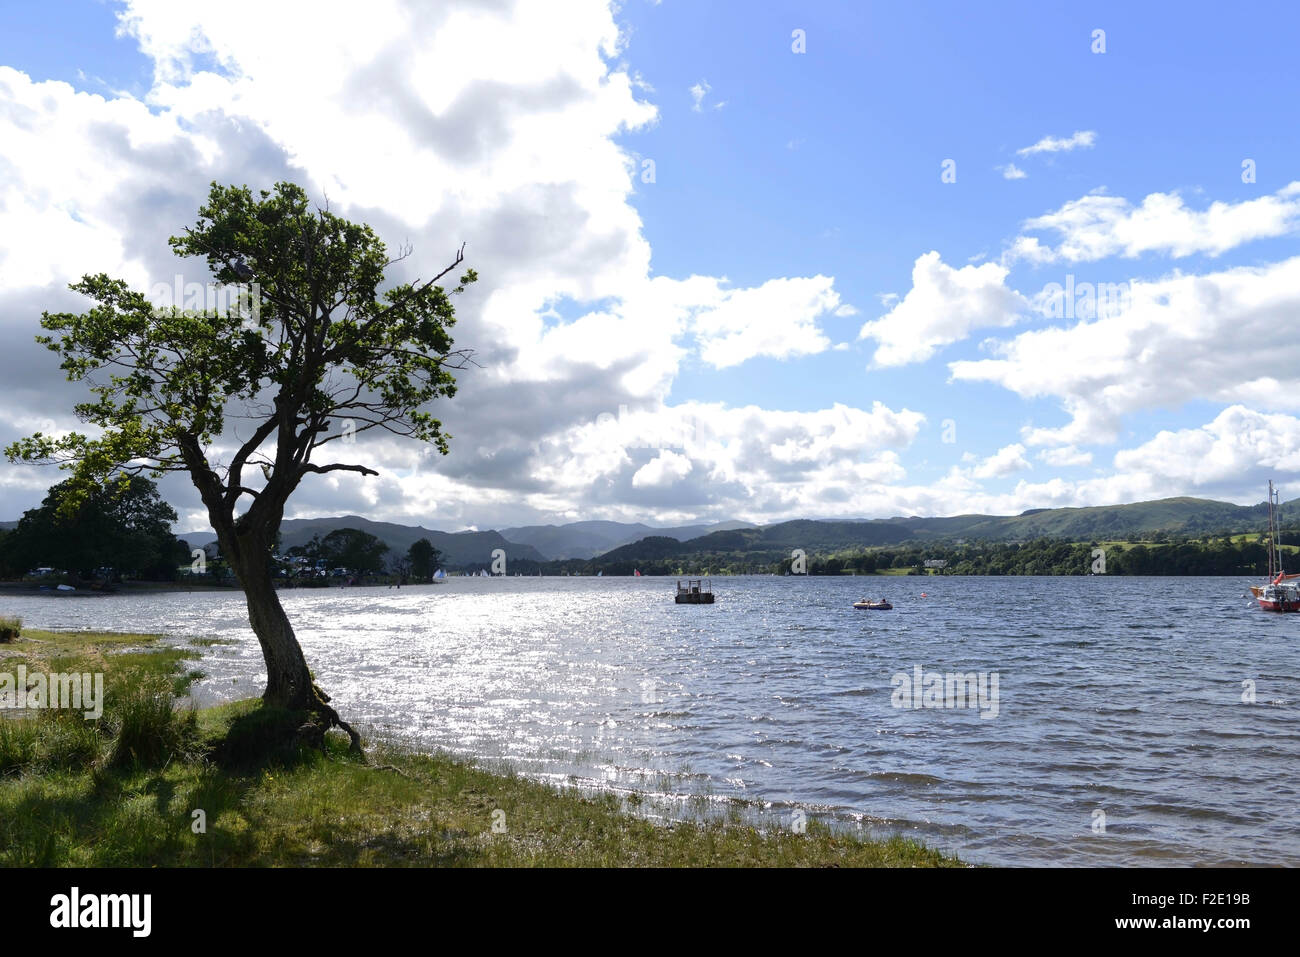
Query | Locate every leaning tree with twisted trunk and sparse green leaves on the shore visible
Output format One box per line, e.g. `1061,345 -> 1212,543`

5,183 -> 477,750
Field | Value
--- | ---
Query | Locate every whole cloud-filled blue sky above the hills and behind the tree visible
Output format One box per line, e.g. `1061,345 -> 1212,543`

0,0 -> 1300,527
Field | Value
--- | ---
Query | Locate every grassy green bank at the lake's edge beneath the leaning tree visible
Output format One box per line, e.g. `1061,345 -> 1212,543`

0,631 -> 963,867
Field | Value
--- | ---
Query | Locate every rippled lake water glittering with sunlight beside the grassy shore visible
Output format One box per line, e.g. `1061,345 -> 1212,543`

0,576 -> 1300,866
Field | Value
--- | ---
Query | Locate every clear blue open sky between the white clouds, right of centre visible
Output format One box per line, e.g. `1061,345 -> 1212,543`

624,3 -> 1300,429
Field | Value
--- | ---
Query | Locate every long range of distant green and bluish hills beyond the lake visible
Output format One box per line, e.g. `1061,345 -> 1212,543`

157,498 -> 1300,567
